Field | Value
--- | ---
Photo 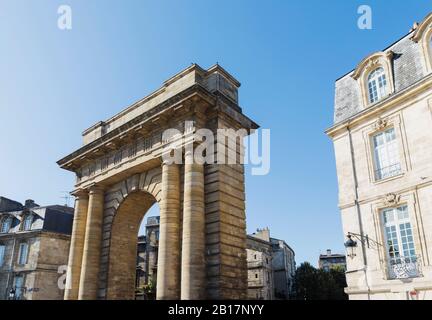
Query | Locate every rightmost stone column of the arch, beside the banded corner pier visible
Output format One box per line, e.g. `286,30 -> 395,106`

181,151 -> 205,300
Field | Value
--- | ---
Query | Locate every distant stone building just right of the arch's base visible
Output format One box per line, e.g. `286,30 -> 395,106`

247,228 -> 295,300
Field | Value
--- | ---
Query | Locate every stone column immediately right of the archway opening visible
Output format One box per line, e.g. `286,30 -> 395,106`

157,162 -> 180,300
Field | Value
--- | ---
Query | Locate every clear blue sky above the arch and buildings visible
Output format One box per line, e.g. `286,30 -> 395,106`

0,0 -> 431,264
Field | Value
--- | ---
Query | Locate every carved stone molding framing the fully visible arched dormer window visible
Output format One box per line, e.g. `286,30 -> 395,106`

351,51 -> 394,107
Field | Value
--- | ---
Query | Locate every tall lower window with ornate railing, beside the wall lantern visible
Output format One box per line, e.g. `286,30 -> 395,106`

382,205 -> 419,278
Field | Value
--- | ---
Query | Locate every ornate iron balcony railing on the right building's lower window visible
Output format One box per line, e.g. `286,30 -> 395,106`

387,255 -> 423,279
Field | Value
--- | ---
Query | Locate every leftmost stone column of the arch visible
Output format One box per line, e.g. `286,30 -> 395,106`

64,190 -> 88,300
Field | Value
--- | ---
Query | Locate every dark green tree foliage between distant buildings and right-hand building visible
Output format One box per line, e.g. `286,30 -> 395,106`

293,262 -> 348,300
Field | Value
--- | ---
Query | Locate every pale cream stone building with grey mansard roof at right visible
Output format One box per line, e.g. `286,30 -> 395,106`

327,14 -> 432,300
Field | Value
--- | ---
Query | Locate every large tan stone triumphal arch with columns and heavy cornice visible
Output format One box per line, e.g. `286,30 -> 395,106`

58,64 -> 258,300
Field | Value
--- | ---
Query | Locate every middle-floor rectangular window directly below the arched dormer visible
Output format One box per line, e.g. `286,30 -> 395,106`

373,128 -> 401,180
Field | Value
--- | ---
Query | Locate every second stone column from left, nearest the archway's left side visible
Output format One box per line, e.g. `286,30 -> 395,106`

78,186 -> 104,300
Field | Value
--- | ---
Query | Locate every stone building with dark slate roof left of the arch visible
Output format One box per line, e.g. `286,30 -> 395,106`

0,197 -> 73,300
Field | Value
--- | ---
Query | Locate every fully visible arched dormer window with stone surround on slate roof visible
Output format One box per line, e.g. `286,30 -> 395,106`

351,51 -> 394,108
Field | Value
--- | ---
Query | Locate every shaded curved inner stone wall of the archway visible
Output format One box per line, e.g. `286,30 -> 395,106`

107,191 -> 159,300
